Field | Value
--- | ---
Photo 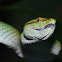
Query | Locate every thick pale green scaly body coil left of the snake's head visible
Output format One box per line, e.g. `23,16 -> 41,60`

0,22 -> 23,57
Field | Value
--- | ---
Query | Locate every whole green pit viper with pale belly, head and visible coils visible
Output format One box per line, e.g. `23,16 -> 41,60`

0,17 -> 61,60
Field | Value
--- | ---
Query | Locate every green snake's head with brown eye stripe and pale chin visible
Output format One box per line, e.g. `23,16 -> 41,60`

23,17 -> 56,43
